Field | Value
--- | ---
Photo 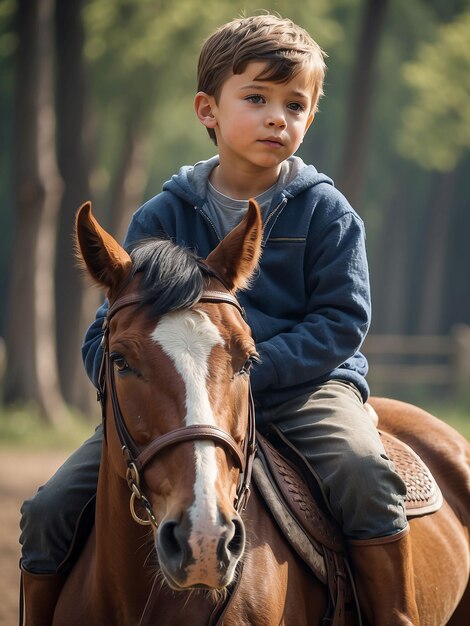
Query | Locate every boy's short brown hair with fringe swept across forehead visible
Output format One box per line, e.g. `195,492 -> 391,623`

197,14 -> 326,141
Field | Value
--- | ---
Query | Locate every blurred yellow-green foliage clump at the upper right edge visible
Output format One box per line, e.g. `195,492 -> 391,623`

398,10 -> 470,171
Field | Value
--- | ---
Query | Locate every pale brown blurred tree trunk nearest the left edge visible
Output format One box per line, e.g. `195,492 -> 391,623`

5,0 -> 66,423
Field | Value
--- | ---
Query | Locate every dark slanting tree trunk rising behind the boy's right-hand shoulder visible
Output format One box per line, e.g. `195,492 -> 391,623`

338,0 -> 388,206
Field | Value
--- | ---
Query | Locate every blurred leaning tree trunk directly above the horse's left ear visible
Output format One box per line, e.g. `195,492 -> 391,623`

109,111 -> 151,241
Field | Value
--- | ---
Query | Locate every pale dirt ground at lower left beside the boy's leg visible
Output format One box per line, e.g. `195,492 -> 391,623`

0,450 -> 67,626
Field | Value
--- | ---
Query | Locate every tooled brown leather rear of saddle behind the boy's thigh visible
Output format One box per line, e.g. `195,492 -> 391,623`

379,430 -> 442,519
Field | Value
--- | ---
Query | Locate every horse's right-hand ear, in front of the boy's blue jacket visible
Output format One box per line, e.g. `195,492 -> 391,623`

207,200 -> 263,290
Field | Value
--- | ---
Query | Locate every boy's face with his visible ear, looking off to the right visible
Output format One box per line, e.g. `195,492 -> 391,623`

195,61 -> 313,173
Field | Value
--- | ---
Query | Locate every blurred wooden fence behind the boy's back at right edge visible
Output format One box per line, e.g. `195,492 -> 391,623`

362,324 -> 470,395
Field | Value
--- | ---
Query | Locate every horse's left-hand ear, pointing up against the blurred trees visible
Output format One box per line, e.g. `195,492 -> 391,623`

75,202 -> 132,291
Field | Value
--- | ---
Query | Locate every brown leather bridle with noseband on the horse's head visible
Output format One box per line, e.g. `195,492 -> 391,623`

97,289 -> 256,528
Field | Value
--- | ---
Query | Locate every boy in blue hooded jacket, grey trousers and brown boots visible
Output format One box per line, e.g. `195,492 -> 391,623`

21,15 -> 419,626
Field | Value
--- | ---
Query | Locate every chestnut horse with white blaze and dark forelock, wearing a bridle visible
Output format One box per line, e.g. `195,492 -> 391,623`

53,202 -> 470,626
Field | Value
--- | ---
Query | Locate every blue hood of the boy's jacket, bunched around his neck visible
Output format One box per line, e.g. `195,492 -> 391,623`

163,155 -> 333,207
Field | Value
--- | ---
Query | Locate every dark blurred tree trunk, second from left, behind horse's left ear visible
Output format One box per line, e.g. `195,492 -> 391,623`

55,0 -> 98,413
